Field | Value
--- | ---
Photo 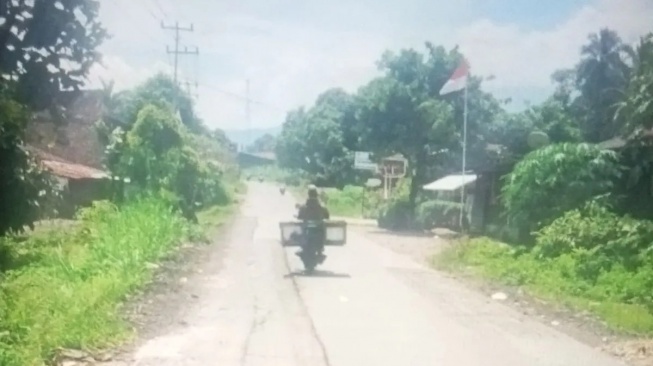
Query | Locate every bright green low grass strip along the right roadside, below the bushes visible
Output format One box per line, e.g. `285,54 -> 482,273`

433,238 -> 653,336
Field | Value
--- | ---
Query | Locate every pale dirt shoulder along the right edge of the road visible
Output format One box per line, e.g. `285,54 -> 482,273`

349,224 -> 653,366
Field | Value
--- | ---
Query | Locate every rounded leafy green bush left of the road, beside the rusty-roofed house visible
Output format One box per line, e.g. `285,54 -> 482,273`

107,105 -> 231,220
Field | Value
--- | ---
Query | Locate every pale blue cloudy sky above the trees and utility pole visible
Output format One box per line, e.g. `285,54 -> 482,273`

89,0 -> 653,129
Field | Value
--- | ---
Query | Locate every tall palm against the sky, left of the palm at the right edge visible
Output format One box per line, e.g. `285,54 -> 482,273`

576,28 -> 632,142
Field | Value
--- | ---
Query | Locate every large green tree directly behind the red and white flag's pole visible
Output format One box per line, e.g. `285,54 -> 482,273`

357,43 -> 501,209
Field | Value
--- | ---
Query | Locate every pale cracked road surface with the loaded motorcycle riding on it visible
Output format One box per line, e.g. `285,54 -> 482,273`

119,183 -> 621,366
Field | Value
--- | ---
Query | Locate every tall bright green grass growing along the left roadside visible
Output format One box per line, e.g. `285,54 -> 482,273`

0,198 -> 188,366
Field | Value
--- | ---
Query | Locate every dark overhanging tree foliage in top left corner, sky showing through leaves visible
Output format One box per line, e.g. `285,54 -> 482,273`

0,0 -> 106,115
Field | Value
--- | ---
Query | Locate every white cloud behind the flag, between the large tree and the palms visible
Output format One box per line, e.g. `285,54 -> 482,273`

458,0 -> 653,91
